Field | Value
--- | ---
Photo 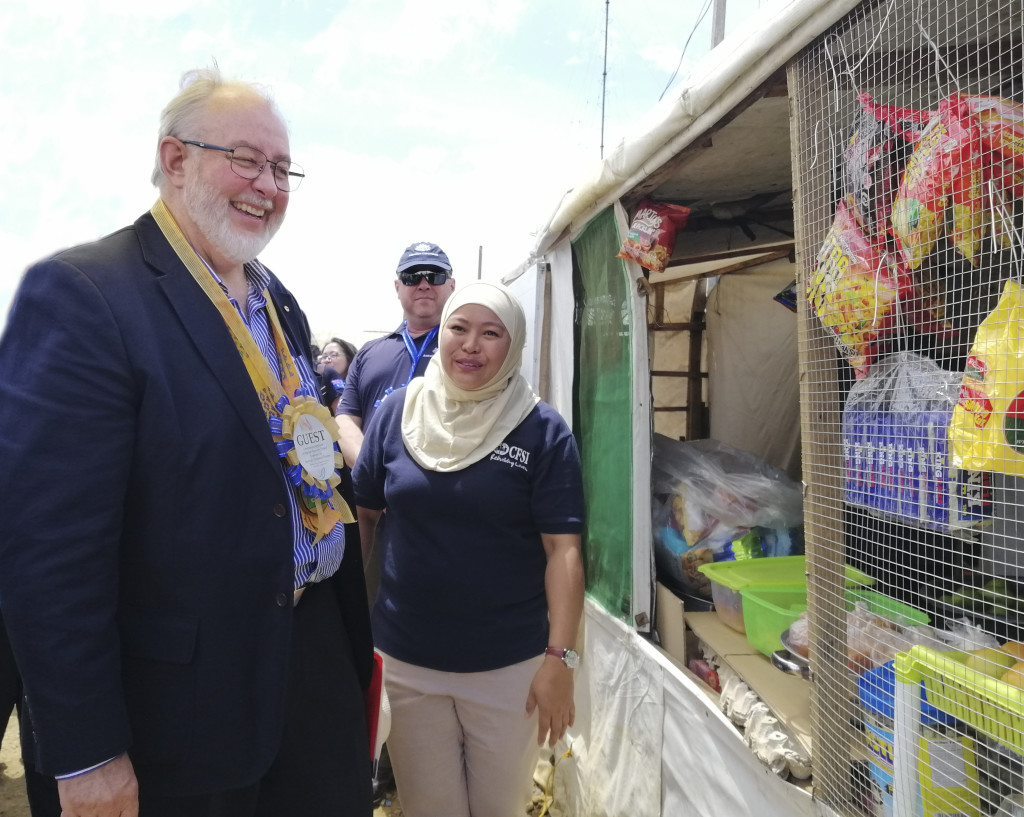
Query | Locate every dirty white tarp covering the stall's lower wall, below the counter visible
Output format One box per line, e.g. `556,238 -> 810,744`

552,602 -> 816,817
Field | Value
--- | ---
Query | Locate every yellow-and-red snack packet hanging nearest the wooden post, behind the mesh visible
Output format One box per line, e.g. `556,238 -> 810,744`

807,201 -> 911,379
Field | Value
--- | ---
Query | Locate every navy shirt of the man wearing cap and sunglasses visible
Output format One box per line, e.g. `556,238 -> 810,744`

335,324 -> 437,434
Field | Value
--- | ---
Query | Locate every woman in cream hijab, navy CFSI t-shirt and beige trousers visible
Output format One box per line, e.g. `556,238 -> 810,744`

352,282 -> 584,817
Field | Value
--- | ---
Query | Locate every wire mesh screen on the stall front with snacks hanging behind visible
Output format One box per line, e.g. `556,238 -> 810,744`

790,0 -> 1024,817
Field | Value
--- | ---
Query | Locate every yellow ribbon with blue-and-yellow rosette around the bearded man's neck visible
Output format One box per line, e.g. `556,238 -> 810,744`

150,200 -> 355,544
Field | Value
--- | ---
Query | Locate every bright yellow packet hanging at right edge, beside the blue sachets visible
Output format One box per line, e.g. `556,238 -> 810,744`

949,280 -> 1024,477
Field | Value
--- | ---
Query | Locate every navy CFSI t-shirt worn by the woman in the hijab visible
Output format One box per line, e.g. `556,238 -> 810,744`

354,389 -> 584,673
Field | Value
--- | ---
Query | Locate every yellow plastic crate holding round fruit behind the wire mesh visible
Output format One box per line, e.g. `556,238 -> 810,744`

909,647 -> 1024,755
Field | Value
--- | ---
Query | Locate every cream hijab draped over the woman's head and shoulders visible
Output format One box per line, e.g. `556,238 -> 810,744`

401,282 -> 541,471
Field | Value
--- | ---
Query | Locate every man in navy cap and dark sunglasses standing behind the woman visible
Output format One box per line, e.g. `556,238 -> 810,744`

337,242 -> 455,477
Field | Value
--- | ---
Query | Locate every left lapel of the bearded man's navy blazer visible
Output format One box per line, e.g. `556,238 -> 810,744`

135,213 -> 281,477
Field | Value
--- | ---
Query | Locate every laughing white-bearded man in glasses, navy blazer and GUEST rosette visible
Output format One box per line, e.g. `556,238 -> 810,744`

0,69 -> 373,817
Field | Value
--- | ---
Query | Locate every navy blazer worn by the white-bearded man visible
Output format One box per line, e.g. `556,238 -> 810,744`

0,214 -> 373,794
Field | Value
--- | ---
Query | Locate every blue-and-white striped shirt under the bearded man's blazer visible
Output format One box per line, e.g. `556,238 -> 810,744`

214,261 -> 345,588
